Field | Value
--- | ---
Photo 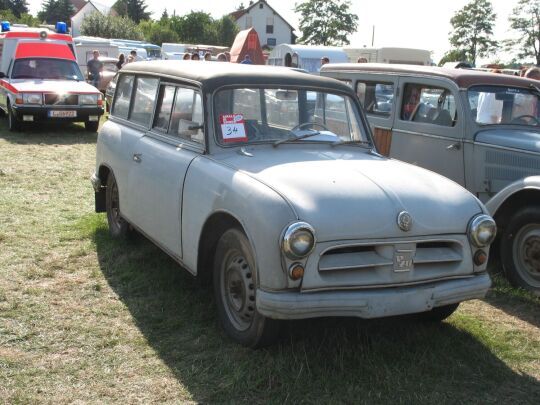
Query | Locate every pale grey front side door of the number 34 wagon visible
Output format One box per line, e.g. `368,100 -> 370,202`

128,82 -> 204,258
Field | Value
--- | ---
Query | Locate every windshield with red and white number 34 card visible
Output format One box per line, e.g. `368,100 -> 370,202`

215,88 -> 369,145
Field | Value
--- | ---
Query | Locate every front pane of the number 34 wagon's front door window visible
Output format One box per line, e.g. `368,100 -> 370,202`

169,87 -> 204,144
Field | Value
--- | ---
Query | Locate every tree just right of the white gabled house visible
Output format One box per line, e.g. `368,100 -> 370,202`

294,0 -> 358,45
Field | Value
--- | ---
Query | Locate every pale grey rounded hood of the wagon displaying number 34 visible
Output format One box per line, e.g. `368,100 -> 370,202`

213,145 -> 482,241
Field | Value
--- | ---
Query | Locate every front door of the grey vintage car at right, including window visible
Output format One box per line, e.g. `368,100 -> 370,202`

390,77 -> 465,186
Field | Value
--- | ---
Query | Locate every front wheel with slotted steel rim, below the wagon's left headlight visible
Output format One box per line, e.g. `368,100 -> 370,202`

213,228 -> 280,349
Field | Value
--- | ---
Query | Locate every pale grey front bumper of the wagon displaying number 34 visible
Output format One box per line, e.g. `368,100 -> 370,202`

257,273 -> 491,319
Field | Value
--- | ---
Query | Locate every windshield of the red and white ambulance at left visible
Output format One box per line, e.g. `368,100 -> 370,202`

11,58 -> 84,81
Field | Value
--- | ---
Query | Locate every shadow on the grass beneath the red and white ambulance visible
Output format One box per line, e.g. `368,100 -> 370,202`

0,118 -> 97,145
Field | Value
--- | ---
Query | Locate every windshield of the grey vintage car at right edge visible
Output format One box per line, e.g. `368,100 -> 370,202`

468,86 -> 540,126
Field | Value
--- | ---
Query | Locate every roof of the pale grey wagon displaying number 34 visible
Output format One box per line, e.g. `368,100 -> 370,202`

122,60 -> 353,93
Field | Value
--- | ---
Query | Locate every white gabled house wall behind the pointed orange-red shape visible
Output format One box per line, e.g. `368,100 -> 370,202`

236,3 -> 292,46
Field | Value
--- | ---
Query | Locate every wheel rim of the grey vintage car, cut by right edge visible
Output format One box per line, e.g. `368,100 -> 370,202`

513,224 -> 540,287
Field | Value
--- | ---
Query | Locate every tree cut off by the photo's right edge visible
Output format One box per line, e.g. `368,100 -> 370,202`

507,0 -> 540,66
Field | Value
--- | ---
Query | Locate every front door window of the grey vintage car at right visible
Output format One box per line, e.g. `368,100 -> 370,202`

401,84 -> 457,127
